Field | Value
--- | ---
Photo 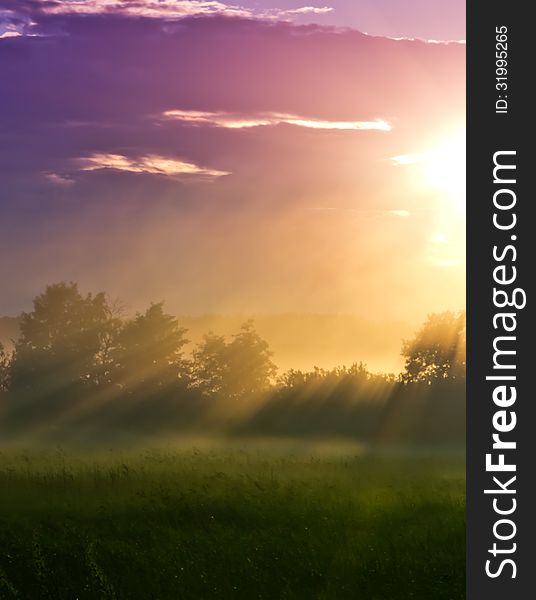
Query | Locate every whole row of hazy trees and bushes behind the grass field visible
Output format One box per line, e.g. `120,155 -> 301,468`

0,283 -> 465,441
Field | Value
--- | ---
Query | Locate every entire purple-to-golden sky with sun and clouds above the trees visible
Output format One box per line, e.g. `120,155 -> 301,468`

0,0 -> 465,321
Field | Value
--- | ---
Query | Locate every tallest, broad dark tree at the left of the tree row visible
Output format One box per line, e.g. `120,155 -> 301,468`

11,283 -> 116,398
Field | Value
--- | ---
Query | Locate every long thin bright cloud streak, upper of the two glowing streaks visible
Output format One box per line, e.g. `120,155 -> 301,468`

163,110 -> 392,131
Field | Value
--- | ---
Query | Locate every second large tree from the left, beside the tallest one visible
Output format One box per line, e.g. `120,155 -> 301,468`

113,303 -> 188,391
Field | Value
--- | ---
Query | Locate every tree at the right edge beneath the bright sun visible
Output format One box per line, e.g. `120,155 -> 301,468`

402,311 -> 466,383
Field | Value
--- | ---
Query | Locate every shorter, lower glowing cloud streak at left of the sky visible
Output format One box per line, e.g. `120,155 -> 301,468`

78,153 -> 229,177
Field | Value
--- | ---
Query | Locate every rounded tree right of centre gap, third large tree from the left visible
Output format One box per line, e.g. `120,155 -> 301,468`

192,321 -> 277,401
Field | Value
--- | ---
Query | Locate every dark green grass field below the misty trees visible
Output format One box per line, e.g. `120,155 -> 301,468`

0,444 -> 465,600
